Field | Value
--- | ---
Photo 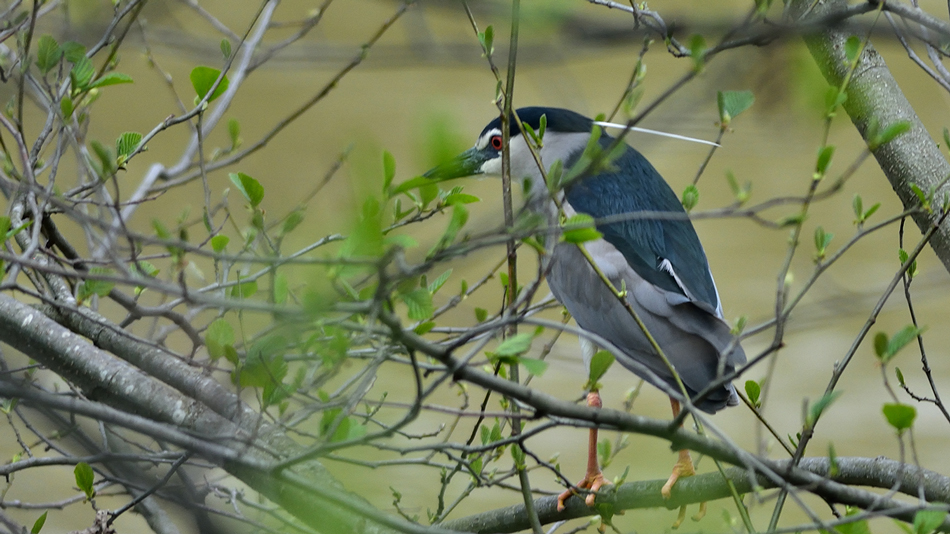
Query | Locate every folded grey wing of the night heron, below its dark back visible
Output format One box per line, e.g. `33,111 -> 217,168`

548,239 -> 745,413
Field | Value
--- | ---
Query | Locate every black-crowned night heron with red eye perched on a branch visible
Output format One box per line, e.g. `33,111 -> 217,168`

424,107 -> 746,510
